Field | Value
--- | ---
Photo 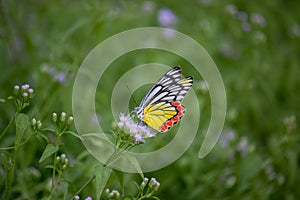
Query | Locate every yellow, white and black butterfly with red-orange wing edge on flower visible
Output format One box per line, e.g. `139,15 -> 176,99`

135,66 -> 193,132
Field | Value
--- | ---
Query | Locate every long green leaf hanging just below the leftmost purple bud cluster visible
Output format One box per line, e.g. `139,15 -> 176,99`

15,113 -> 29,147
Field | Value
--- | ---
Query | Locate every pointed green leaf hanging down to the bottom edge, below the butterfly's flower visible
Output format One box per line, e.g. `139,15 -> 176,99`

95,164 -> 112,200
